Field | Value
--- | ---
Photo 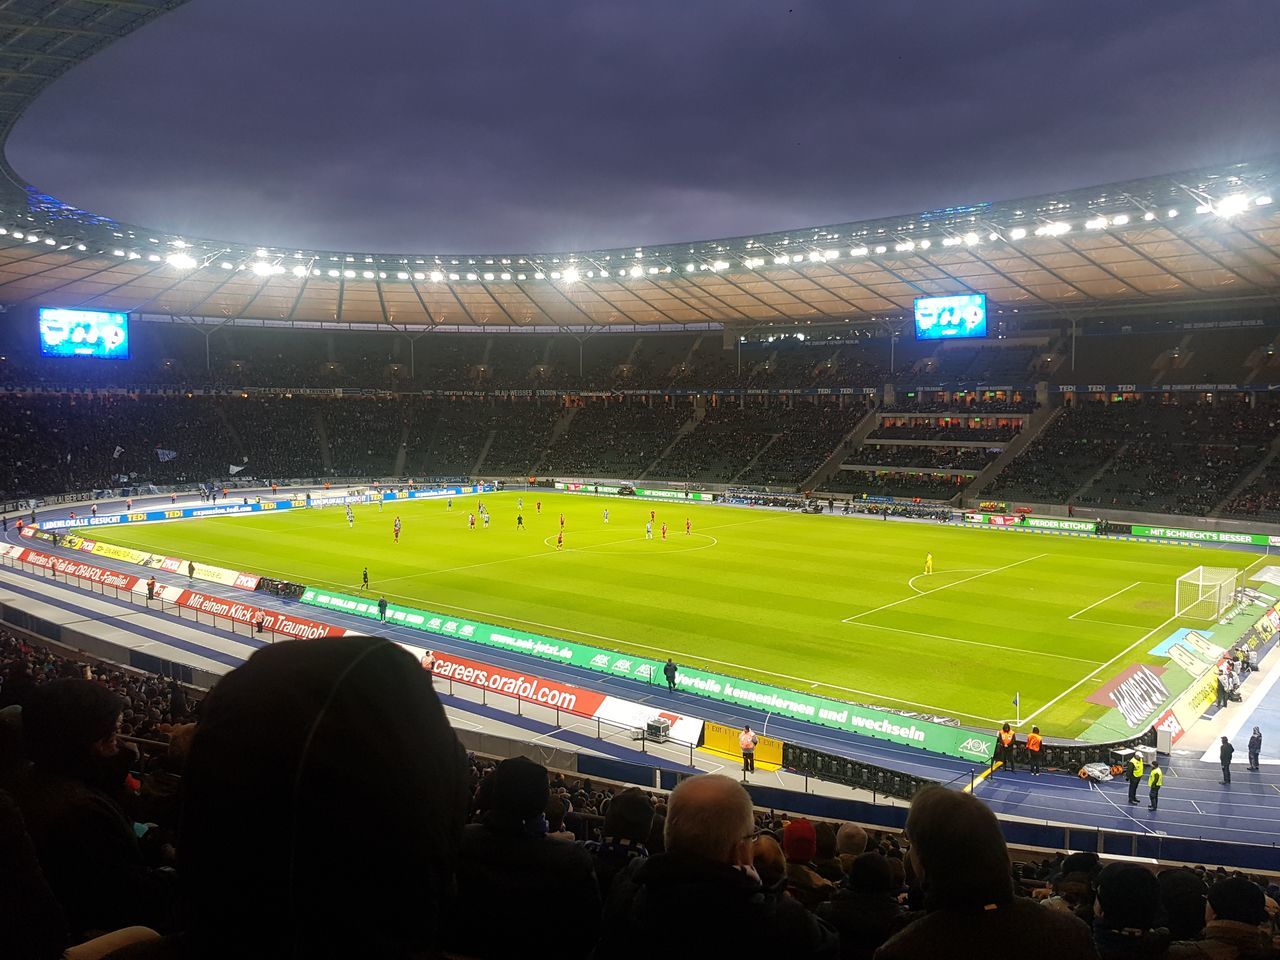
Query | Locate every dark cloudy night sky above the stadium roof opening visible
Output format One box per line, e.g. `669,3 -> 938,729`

8,0 -> 1280,252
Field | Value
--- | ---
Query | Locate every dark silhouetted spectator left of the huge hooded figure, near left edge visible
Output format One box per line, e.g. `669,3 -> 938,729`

15,677 -> 175,937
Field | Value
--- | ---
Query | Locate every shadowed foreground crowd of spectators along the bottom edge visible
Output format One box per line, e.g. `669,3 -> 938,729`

0,637 -> 1280,960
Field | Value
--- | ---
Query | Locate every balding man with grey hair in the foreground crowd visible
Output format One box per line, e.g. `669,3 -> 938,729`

595,774 -> 840,960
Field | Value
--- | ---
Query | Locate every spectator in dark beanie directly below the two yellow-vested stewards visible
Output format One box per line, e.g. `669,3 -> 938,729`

1093,863 -> 1169,960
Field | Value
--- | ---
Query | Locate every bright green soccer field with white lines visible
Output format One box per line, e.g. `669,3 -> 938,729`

92,492 -> 1257,736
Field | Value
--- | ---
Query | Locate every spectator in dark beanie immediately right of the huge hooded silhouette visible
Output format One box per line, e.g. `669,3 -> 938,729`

445,756 -> 600,960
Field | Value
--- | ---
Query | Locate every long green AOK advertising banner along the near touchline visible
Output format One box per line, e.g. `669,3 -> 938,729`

301,588 -> 995,763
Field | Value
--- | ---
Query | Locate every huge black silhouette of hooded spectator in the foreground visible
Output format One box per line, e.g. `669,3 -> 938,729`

103,636 -> 467,960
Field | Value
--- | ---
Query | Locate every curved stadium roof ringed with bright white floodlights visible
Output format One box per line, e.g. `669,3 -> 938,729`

0,0 -> 1280,330
